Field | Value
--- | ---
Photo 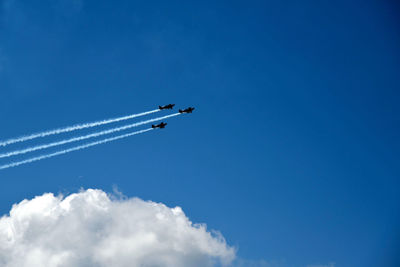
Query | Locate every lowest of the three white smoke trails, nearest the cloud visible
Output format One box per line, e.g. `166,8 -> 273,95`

0,128 -> 153,170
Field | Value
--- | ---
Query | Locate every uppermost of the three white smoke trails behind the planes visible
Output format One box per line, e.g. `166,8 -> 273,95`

0,109 -> 160,146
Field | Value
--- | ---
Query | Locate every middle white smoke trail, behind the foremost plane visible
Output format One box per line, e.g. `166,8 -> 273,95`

0,113 -> 180,158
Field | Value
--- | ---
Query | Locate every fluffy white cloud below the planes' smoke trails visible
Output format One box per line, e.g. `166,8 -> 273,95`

0,189 -> 235,267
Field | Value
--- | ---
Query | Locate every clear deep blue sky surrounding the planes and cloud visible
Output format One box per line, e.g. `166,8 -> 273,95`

0,0 -> 400,266
